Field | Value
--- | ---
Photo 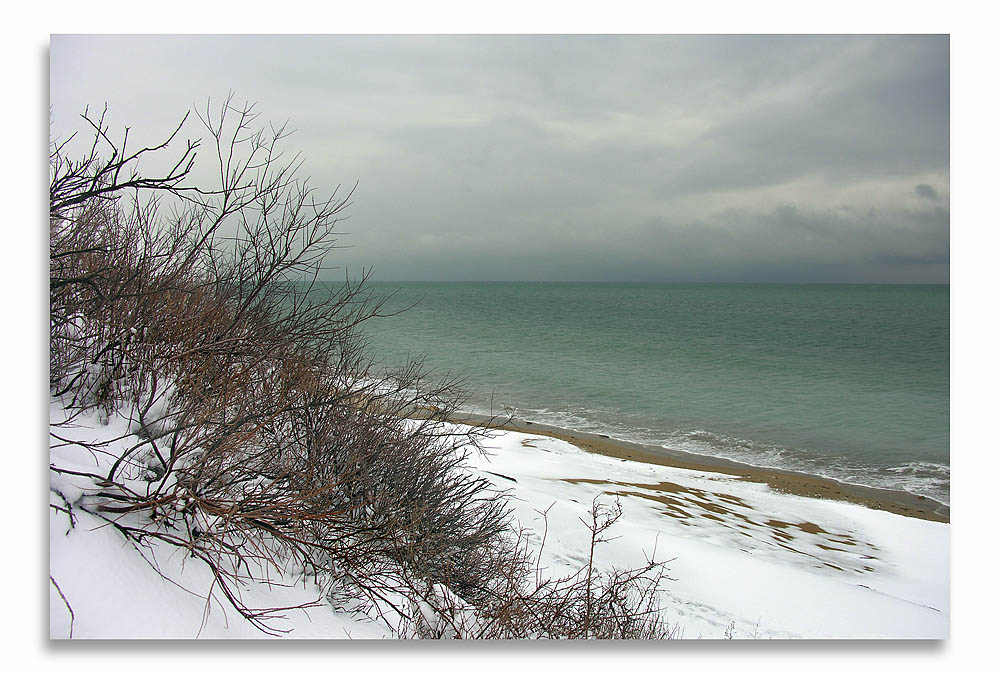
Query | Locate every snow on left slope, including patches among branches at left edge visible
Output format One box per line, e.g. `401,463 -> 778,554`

49,402 -> 398,638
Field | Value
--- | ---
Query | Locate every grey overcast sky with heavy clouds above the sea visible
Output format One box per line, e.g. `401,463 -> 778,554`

50,36 -> 950,283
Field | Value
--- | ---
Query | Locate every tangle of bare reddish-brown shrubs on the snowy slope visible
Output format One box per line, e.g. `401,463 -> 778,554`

50,97 -> 680,638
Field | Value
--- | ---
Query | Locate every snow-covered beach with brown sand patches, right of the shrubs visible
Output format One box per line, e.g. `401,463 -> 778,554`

464,432 -> 949,638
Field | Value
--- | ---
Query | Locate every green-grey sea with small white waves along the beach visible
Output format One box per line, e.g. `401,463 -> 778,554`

350,282 -> 950,504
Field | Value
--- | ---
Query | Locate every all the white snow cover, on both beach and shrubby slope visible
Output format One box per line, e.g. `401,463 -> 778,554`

49,404 -> 950,639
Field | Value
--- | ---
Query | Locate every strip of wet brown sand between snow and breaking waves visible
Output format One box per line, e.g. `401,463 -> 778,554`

448,414 -> 951,523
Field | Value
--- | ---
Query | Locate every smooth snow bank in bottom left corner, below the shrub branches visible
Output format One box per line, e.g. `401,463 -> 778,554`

49,510 -> 389,638
